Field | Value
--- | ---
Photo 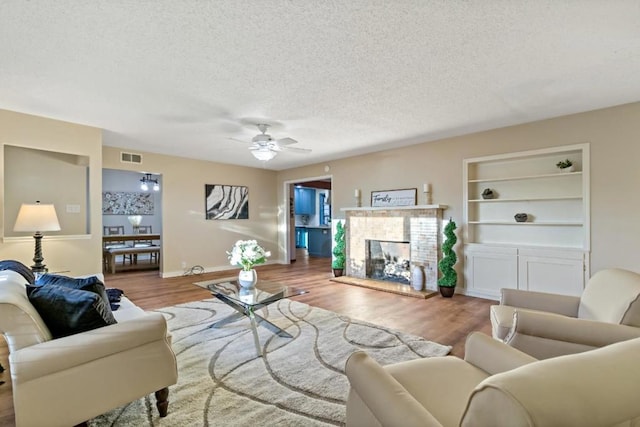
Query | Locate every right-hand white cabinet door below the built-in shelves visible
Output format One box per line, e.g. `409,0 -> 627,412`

518,249 -> 586,296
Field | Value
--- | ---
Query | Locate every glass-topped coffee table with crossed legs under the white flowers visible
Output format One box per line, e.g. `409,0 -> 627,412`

202,280 -> 307,356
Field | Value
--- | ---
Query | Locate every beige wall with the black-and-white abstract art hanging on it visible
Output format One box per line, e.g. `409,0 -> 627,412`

102,147 -> 283,277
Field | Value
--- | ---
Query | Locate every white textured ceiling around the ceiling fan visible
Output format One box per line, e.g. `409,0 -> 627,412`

0,0 -> 640,170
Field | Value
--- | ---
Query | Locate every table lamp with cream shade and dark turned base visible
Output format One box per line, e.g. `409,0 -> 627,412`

13,201 -> 60,273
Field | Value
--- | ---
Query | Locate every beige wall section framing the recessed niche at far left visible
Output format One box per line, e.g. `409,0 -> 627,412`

0,110 -> 102,274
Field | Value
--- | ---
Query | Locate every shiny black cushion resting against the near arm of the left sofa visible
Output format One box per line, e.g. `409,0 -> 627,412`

27,284 -> 116,338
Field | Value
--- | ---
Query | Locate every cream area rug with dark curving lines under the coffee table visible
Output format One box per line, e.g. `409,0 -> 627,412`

89,299 -> 450,427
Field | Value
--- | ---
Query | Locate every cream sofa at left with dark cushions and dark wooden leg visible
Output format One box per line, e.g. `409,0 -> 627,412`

0,270 -> 177,427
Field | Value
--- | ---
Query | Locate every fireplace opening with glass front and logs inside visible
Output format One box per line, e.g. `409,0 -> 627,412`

365,240 -> 411,285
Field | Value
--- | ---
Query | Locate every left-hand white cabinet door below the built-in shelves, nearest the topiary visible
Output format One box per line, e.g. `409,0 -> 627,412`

465,245 -> 518,299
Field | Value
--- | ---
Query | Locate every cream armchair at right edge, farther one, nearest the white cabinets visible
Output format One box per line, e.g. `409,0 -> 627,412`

490,268 -> 640,359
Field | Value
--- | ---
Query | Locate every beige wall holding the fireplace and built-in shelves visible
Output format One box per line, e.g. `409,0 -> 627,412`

278,103 -> 640,274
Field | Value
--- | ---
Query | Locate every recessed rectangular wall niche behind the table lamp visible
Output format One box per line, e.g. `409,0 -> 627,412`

4,145 -> 90,237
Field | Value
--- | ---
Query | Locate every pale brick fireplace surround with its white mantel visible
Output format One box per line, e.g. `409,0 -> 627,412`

342,205 -> 447,290
